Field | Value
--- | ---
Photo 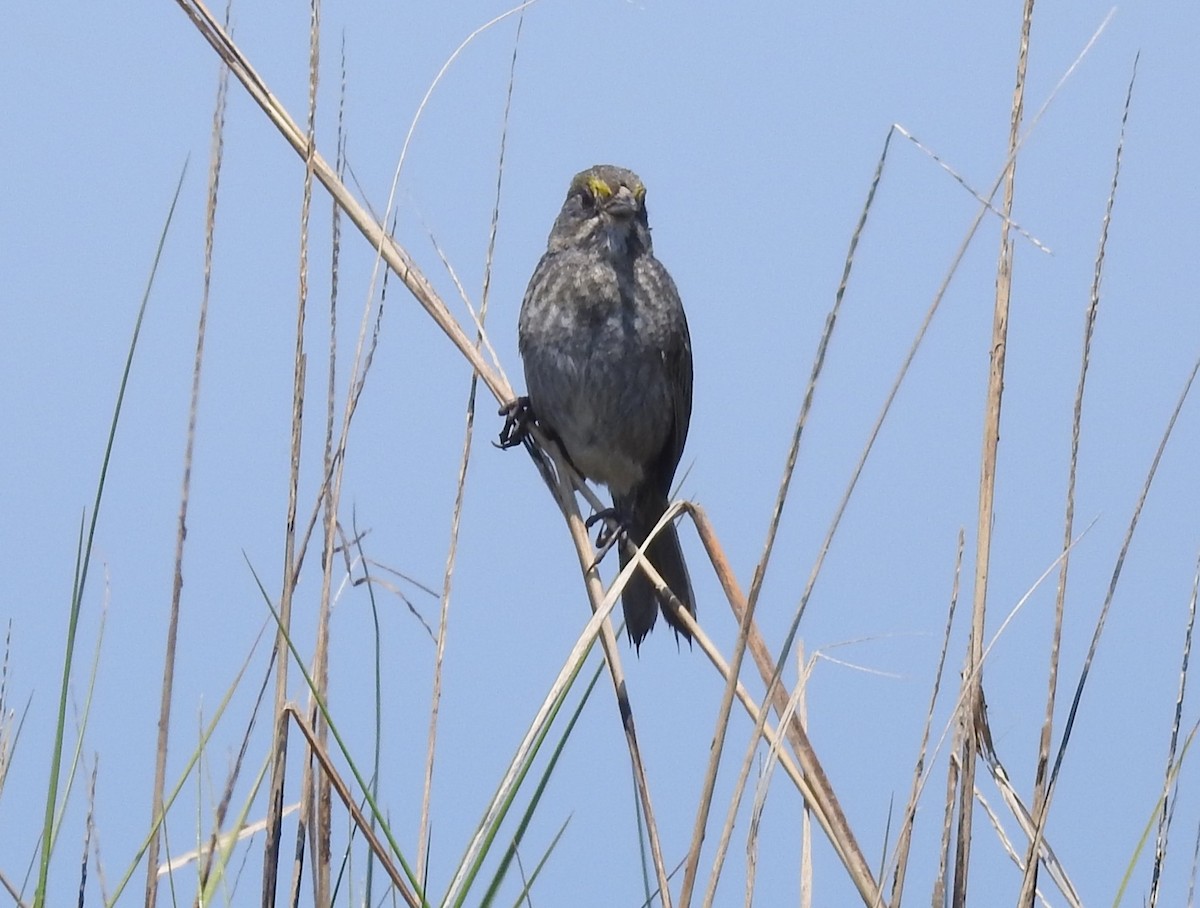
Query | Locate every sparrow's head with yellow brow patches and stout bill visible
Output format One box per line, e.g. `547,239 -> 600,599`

550,164 -> 650,257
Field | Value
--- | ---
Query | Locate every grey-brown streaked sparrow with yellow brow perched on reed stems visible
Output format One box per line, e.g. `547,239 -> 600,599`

517,164 -> 696,650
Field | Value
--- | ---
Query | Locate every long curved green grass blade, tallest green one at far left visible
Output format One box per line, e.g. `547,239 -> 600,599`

34,161 -> 187,908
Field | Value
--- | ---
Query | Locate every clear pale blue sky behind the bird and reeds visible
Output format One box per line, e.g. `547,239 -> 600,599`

0,0 -> 1200,904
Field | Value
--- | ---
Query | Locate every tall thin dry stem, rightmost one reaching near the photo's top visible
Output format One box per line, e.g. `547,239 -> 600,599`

1016,56 -> 1138,906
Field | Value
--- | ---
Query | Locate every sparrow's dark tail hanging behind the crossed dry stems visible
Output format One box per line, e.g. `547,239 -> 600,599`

613,494 -> 696,647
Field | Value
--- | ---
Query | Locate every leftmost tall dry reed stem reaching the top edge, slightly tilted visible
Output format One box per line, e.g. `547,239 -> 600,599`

144,0 -> 232,908
